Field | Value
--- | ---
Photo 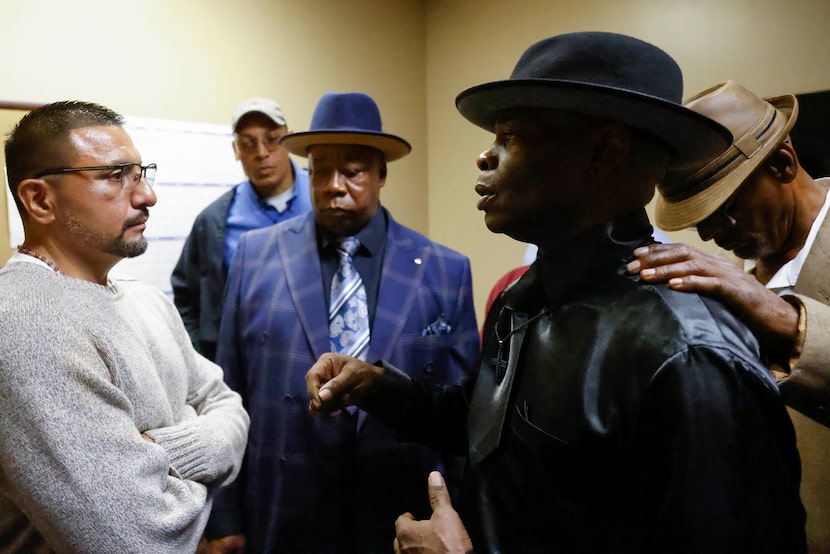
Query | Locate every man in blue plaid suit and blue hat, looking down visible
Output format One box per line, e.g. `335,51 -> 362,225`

208,93 -> 480,553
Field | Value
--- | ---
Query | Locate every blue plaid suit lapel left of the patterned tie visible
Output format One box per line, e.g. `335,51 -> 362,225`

277,214 -> 330,358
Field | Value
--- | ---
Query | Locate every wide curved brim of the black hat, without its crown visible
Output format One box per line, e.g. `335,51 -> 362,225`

455,79 -> 732,167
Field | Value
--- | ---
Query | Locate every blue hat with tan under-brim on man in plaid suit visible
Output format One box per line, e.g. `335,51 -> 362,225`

280,92 -> 412,162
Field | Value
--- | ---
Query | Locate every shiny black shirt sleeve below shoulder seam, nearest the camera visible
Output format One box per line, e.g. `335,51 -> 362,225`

626,346 -> 804,553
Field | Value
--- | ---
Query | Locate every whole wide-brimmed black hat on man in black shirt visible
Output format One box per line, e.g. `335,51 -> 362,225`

455,32 -> 732,167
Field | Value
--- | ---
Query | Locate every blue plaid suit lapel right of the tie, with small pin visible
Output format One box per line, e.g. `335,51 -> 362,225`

368,216 -> 431,360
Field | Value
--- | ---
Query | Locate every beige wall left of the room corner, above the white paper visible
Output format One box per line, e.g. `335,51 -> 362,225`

0,0 -> 427,264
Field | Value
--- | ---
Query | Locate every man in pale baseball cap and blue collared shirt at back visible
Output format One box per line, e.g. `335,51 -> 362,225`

170,98 -> 311,359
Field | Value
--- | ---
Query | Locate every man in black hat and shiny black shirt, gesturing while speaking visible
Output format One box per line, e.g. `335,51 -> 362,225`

306,32 -> 805,554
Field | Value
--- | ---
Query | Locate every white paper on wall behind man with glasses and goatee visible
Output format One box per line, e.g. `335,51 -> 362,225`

6,112 -> 245,294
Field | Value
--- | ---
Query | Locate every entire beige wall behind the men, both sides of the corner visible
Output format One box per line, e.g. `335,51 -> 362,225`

0,0 -> 830,317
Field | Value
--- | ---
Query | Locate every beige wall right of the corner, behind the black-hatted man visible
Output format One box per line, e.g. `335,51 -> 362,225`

426,0 -> 830,320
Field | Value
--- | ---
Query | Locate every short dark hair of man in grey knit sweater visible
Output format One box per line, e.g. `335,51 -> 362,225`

5,100 -> 124,211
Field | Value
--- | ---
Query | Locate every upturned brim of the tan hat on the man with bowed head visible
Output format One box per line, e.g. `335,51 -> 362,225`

654,95 -> 798,231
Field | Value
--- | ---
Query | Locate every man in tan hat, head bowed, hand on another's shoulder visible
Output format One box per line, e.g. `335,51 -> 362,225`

629,81 -> 830,552
